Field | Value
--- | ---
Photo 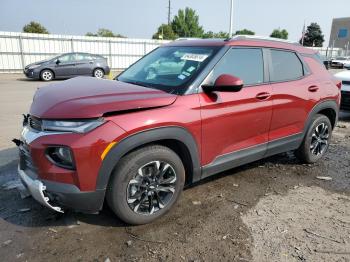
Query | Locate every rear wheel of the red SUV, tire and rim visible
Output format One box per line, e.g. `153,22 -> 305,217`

295,114 -> 332,164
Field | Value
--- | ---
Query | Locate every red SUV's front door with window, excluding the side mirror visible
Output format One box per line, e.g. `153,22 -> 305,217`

199,47 -> 272,177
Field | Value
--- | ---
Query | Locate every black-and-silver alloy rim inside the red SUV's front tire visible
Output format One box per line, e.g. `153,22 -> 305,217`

127,161 -> 177,215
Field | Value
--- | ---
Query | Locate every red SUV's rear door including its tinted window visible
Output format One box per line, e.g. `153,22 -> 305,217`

267,49 -> 320,155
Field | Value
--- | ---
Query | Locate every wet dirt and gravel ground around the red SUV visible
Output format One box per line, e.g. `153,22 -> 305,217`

0,75 -> 350,262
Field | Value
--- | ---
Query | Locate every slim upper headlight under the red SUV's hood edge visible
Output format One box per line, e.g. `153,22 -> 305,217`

42,118 -> 105,133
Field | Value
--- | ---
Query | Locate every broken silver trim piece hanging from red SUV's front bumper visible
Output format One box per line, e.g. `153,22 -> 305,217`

18,168 -> 64,213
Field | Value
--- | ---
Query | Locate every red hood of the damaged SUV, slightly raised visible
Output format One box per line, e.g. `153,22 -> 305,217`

30,77 -> 177,119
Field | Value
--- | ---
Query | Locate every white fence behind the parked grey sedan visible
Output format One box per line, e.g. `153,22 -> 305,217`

0,31 -> 168,73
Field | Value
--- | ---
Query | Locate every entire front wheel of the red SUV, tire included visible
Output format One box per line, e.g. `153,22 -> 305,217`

106,145 -> 185,225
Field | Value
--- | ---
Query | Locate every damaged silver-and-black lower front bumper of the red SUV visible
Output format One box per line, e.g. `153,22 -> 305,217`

18,168 -> 105,213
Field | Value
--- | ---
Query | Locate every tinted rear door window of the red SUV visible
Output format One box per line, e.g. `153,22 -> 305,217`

271,50 -> 304,82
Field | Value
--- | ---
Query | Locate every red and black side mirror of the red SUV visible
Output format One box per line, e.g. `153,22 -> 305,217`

202,74 -> 244,92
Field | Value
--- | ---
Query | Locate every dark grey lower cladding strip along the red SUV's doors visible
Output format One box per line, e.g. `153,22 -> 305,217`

201,133 -> 303,179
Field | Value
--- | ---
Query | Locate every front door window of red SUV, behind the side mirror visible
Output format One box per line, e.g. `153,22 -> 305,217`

207,48 -> 264,85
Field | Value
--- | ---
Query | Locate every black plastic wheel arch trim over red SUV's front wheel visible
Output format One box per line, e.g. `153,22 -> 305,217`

96,126 -> 201,190
